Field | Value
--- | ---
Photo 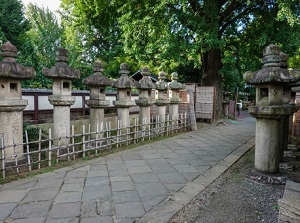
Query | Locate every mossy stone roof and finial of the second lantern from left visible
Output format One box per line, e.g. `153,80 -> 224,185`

42,48 -> 80,80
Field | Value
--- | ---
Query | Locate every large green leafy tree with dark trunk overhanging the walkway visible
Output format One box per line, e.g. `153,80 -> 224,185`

59,0 -> 300,116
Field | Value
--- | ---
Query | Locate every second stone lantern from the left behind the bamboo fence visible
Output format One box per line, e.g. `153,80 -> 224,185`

43,48 -> 80,145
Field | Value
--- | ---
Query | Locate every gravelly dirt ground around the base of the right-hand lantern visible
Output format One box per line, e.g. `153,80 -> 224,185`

169,145 -> 300,223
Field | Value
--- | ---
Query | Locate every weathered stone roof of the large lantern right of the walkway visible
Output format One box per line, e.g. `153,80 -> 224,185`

244,44 -> 300,85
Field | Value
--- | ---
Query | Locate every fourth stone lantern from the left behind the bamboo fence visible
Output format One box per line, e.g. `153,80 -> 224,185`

113,63 -> 135,128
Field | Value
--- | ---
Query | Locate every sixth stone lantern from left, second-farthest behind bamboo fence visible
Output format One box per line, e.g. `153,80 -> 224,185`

155,71 -> 169,121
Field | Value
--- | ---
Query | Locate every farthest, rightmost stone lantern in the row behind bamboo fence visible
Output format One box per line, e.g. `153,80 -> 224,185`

168,72 -> 185,121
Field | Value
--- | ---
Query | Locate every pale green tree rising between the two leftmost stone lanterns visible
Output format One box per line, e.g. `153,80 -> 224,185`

19,3 -> 64,88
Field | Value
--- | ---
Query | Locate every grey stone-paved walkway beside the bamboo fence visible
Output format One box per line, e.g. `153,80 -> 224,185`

0,118 -> 255,223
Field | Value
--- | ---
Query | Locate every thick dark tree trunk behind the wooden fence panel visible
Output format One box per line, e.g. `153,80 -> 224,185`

200,48 -> 223,120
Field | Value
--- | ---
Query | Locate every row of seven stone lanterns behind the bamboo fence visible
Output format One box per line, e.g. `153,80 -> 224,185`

0,42 -> 184,165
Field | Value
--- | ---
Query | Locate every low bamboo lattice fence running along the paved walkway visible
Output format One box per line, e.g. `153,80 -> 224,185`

0,113 -> 190,178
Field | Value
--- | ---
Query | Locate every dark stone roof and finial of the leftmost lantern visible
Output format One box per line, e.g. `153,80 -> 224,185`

0,42 -> 36,80
